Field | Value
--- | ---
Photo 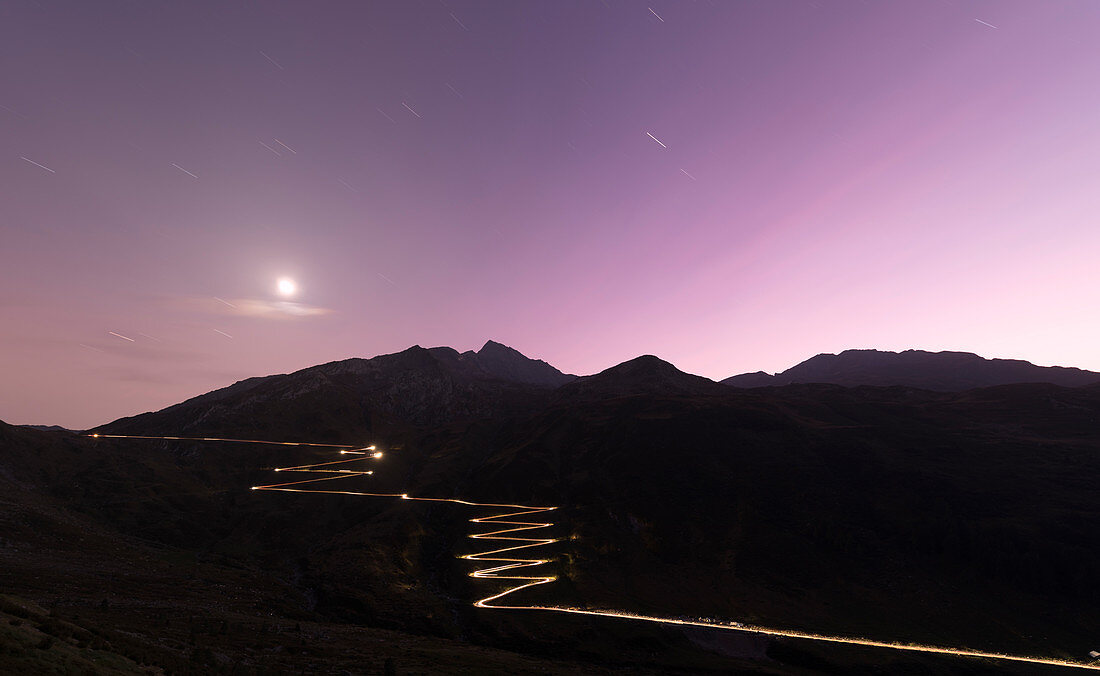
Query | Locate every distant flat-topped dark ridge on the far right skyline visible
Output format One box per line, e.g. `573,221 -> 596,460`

722,350 -> 1100,391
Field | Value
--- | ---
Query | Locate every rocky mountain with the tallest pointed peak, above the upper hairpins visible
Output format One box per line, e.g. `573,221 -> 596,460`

98,341 -> 575,442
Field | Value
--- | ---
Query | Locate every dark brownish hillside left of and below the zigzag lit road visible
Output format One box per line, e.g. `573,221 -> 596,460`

0,423 -> 734,675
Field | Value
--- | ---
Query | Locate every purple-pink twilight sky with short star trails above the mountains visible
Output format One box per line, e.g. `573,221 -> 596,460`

0,0 -> 1100,429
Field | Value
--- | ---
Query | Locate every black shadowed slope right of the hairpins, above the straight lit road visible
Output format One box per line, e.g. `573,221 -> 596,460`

421,378 -> 1100,673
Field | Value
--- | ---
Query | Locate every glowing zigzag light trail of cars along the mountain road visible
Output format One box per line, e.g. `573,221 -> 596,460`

88,434 -> 1100,671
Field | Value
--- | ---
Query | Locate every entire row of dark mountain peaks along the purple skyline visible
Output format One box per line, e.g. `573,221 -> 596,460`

100,341 -> 1100,442
